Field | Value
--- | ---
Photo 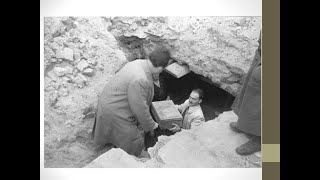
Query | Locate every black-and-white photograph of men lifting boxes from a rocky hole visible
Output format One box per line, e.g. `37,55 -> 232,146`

42,15 -> 263,168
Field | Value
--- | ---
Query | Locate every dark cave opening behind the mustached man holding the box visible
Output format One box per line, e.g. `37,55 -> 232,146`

152,71 -> 235,121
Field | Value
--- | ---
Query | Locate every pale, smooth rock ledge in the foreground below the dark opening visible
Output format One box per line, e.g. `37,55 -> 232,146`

86,111 -> 261,168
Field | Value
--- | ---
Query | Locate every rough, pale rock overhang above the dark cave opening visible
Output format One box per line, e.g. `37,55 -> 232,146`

109,17 -> 261,96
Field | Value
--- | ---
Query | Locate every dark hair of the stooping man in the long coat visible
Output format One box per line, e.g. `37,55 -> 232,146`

149,46 -> 171,68
